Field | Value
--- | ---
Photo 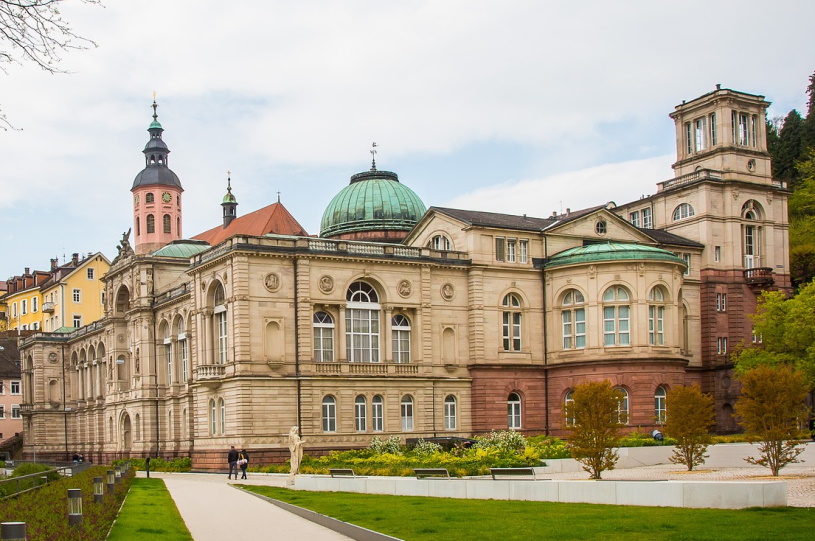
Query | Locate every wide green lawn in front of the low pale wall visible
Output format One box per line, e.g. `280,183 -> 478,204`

243,486 -> 815,541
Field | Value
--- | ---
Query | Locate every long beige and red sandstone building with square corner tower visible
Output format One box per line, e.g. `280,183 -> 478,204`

17,89 -> 789,468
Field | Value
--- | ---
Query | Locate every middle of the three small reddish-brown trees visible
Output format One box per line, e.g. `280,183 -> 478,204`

662,385 -> 716,471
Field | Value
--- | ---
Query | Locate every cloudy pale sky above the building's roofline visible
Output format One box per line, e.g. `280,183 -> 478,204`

0,0 -> 815,279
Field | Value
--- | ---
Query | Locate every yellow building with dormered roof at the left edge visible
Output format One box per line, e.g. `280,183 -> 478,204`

3,253 -> 110,332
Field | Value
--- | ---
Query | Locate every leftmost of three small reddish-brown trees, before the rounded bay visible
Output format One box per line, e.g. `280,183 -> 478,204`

566,381 -> 625,479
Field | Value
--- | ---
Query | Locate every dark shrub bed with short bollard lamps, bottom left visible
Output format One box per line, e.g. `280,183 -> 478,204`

0,466 -> 134,541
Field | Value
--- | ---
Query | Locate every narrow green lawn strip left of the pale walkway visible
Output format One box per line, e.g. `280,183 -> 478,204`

108,478 -> 192,541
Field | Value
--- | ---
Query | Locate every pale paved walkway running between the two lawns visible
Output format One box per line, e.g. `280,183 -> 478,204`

144,472 -> 350,541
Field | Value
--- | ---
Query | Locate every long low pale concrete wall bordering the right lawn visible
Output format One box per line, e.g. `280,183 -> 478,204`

294,475 -> 787,509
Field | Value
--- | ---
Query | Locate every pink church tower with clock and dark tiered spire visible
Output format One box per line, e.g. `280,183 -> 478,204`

130,96 -> 184,254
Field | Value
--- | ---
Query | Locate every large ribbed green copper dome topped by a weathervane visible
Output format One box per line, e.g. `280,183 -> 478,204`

320,170 -> 427,237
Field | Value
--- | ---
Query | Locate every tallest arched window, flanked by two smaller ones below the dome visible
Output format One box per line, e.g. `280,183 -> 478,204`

345,282 -> 380,363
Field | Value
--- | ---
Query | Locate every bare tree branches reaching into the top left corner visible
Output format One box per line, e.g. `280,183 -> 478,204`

0,0 -> 101,129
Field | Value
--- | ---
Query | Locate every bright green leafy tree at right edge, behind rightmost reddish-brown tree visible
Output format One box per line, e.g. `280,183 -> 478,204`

733,281 -> 815,385
